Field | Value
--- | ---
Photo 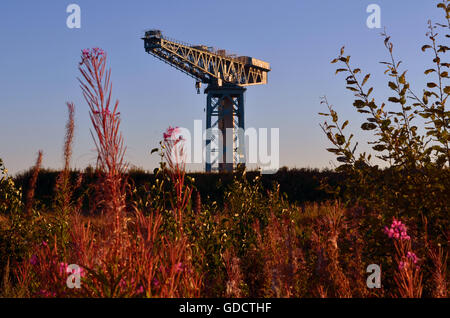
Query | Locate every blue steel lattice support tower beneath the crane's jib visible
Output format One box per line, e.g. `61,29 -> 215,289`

205,85 -> 246,172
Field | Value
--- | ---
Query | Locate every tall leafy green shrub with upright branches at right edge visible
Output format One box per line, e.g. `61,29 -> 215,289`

320,0 -> 450,268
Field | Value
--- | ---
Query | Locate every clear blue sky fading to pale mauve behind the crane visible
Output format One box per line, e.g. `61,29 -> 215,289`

0,0 -> 442,173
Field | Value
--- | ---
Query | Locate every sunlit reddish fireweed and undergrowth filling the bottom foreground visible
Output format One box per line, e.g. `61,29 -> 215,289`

2,155 -> 448,297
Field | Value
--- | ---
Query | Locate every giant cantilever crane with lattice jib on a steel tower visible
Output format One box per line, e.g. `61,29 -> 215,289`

142,30 -> 270,172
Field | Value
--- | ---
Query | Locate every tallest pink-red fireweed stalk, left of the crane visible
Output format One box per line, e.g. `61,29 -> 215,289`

78,48 -> 127,234
